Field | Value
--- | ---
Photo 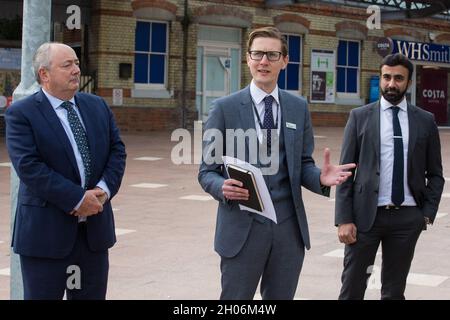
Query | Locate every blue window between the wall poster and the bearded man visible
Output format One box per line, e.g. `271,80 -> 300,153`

336,40 -> 360,94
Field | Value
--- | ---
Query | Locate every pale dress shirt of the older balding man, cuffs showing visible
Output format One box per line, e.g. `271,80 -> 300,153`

42,89 -> 111,221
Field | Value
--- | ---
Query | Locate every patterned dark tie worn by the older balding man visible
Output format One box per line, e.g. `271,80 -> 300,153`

61,101 -> 91,188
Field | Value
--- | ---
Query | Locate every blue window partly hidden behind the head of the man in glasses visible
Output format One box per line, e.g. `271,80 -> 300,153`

278,34 -> 302,92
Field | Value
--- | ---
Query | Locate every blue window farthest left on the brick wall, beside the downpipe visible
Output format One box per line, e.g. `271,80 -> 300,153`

134,21 -> 167,85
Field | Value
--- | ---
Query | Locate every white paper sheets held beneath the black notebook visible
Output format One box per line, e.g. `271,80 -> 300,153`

222,156 -> 277,223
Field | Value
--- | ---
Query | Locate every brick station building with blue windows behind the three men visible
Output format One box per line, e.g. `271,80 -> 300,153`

0,0 -> 450,133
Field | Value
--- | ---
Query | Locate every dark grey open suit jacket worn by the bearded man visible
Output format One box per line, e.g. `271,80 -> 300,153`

335,101 -> 444,232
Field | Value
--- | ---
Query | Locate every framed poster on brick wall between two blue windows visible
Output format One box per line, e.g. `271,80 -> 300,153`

310,49 -> 336,103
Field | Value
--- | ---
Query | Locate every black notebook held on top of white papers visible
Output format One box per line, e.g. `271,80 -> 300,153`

227,164 -> 264,212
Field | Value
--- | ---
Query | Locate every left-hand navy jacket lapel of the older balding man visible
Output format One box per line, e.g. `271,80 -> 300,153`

36,90 -> 80,176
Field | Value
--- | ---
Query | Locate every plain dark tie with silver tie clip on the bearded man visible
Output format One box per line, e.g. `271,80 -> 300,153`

391,106 -> 405,206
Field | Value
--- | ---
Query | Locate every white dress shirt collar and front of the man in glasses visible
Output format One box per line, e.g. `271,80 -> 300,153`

250,80 -> 281,143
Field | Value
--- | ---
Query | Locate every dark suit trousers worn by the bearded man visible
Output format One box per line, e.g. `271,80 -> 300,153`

339,207 -> 425,300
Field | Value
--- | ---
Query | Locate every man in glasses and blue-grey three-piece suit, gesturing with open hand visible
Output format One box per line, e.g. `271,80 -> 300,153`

198,27 -> 354,299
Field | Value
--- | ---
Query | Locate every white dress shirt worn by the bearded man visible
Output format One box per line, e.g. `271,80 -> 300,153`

378,96 -> 416,206
